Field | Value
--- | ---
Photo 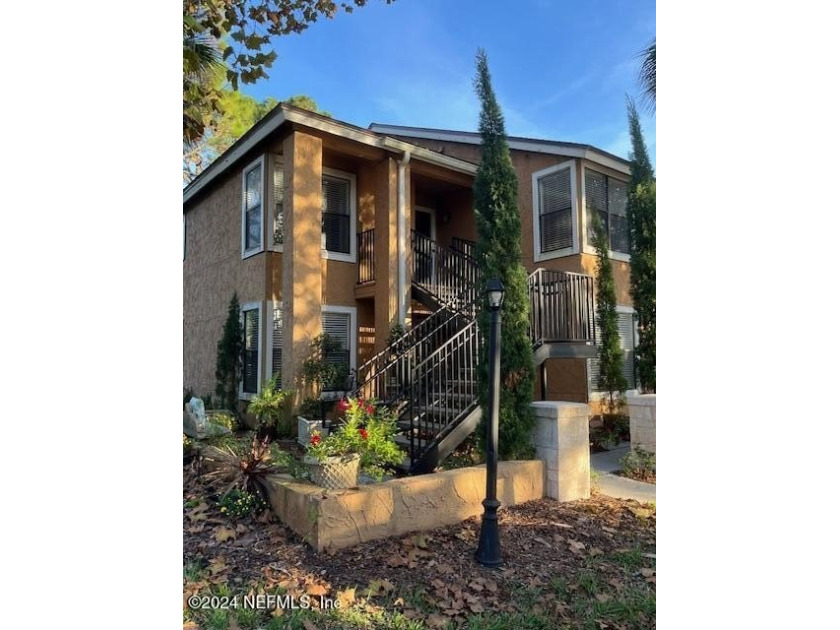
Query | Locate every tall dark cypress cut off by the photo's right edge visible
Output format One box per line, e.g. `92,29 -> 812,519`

627,99 -> 656,393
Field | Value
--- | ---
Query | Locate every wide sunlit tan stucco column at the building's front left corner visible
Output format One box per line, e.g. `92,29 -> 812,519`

283,131 -> 322,403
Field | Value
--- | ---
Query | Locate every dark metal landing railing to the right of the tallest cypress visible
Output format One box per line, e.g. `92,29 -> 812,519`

528,269 -> 595,347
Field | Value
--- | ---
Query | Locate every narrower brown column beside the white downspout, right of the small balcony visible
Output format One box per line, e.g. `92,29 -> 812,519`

374,158 -> 401,352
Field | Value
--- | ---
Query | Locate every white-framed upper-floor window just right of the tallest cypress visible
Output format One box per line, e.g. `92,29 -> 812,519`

532,161 -> 578,261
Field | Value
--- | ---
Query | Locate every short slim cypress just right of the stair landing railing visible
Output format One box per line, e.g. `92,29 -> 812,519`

594,212 -> 627,415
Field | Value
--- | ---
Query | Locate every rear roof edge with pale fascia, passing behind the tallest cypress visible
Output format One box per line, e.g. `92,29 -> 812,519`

369,123 -> 630,175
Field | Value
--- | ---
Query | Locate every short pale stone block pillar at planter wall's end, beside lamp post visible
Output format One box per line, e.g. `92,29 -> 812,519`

531,401 -> 590,501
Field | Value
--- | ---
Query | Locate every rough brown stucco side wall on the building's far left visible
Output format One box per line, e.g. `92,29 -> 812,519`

183,165 -> 267,395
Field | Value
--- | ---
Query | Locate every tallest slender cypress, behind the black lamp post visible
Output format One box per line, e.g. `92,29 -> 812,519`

473,50 -> 535,459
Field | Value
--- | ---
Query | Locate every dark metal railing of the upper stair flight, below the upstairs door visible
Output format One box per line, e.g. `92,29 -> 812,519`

411,230 -> 478,309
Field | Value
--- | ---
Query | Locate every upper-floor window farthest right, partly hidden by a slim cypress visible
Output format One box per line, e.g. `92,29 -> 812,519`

584,169 -> 630,254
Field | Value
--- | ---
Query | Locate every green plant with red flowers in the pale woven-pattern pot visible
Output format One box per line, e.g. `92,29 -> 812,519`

306,398 -> 403,479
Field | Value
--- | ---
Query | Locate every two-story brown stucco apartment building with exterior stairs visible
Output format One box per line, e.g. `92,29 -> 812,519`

183,104 -> 633,470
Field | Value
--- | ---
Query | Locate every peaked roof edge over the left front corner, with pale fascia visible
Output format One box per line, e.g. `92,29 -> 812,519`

183,103 -> 478,204
